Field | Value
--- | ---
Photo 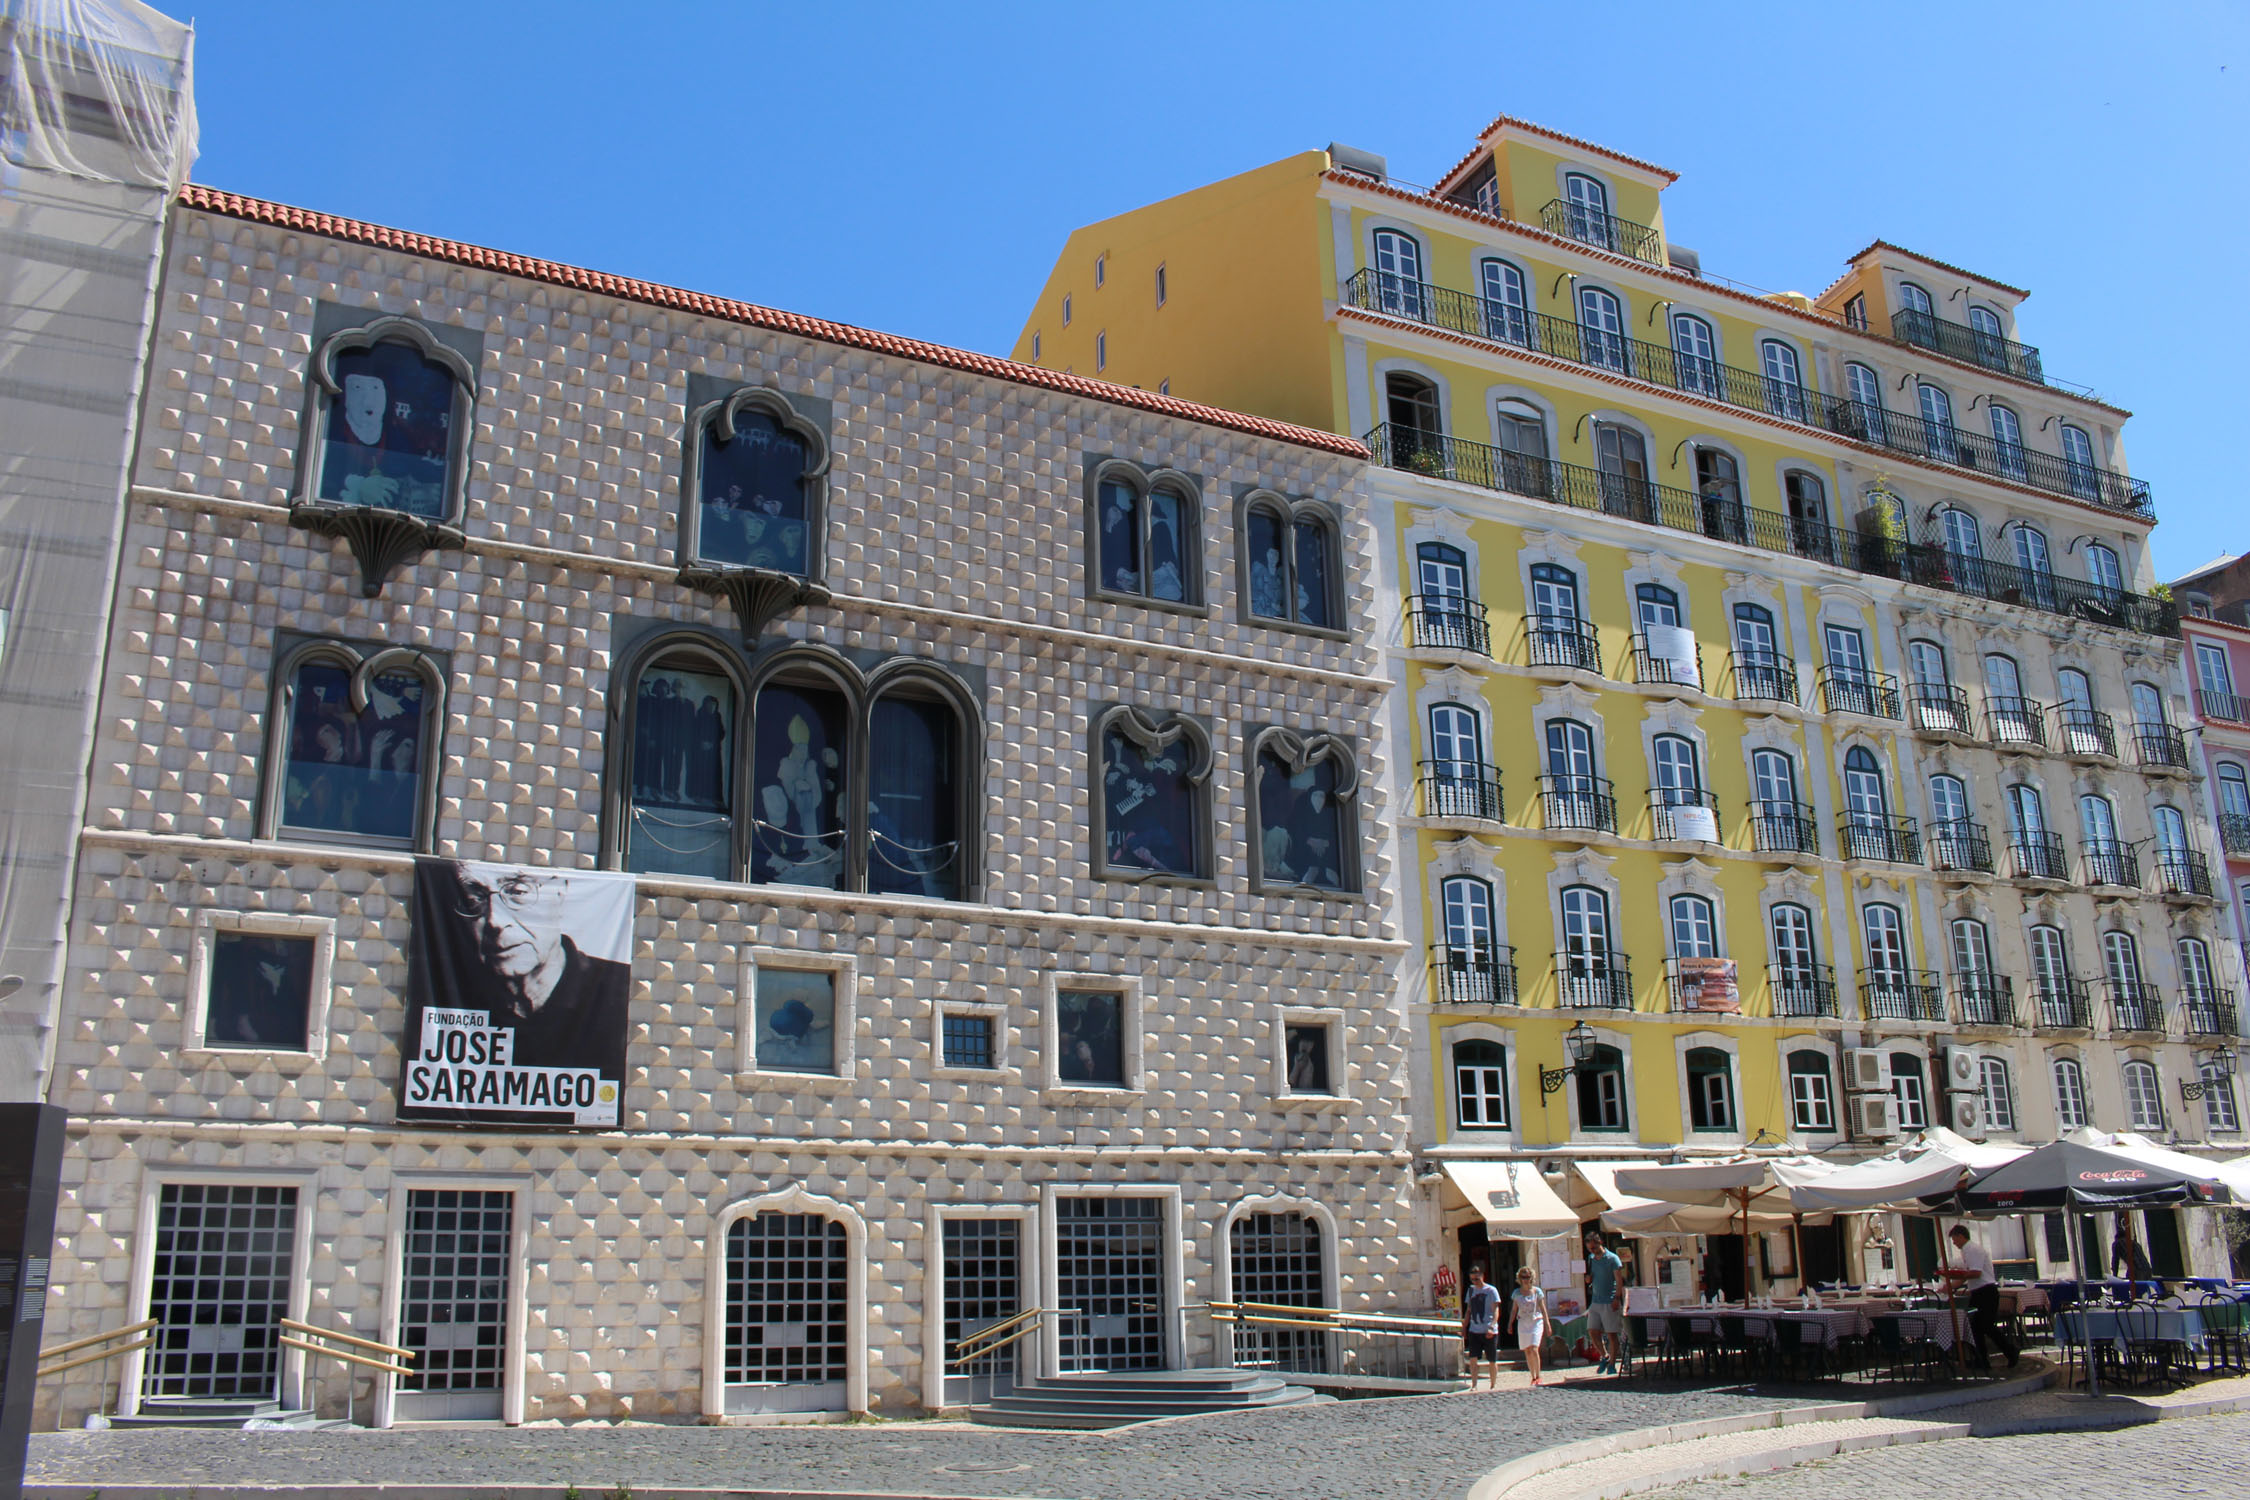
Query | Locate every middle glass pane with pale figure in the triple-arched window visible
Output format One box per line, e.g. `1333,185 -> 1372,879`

749,684 -> 844,891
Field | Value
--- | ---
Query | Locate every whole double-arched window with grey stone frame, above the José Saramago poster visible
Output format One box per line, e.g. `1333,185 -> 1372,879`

259,639 -> 446,850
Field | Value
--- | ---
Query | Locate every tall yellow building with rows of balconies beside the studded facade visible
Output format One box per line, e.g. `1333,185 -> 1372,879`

1013,117 -> 2241,1284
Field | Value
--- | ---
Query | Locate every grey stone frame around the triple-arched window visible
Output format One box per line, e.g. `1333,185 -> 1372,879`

599,623 -> 992,906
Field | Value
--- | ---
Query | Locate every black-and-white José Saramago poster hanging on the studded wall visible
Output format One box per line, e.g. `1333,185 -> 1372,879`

398,857 -> 635,1129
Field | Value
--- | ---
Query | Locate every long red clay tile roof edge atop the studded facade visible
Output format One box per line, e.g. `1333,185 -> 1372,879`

180,182 -> 1368,459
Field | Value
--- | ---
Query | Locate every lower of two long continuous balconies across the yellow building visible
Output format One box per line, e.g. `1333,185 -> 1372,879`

1361,416 -> 2180,638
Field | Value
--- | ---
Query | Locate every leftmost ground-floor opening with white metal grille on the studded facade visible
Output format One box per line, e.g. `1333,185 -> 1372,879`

142,1183 -> 297,1401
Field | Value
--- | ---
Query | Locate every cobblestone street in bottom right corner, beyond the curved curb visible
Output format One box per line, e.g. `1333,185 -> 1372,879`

1647,1412 -> 2250,1500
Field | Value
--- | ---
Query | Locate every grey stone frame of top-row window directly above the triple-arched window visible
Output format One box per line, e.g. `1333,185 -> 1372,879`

675,385 -> 835,643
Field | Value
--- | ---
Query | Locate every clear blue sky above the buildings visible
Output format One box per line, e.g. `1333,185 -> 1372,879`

184,0 -> 2250,576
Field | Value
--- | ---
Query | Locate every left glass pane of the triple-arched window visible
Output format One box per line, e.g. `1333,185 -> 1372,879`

626,659 -> 736,879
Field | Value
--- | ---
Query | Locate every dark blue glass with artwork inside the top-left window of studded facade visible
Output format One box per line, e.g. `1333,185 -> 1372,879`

320,342 -> 452,515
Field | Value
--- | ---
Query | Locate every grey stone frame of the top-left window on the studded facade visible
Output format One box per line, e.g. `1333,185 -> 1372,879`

288,308 -> 477,598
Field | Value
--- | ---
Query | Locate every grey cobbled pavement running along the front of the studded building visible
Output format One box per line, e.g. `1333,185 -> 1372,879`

27,1381 -> 1854,1500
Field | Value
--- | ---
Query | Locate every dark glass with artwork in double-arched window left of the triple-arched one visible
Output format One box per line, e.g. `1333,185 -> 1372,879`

281,659 -> 428,843
